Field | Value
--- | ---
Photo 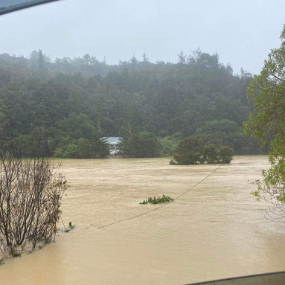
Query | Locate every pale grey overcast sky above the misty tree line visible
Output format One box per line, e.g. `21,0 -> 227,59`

0,0 -> 285,74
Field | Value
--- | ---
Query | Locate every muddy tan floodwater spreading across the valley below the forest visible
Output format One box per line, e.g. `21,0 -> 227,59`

0,156 -> 285,285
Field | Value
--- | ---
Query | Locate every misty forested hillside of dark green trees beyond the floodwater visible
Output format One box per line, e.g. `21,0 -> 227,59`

0,51 -> 261,158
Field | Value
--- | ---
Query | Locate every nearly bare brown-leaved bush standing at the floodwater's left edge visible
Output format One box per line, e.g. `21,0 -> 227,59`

0,157 -> 67,256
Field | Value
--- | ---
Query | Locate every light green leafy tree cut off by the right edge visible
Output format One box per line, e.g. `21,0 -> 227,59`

244,26 -> 285,216
